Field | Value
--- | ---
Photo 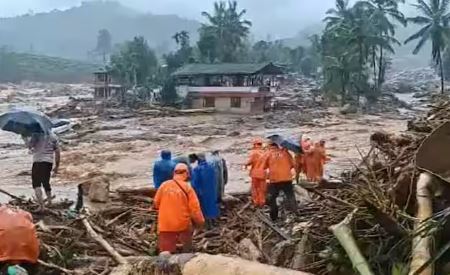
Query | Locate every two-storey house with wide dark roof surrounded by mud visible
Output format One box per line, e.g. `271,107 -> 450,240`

172,63 -> 283,114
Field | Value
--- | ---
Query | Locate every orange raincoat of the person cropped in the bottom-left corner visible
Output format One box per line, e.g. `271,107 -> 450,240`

0,206 -> 39,264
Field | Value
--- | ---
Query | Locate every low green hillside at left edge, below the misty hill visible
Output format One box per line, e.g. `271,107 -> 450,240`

0,50 -> 99,83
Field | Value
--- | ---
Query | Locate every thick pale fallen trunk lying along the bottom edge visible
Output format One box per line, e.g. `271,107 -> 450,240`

111,254 -> 311,275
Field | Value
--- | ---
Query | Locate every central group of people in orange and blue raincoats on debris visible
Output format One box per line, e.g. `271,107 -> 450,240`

153,138 -> 328,253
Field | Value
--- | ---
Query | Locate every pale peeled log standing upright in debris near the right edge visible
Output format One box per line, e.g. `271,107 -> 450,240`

409,172 -> 434,275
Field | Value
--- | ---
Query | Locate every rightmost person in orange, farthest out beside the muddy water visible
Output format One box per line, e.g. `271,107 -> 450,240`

306,141 -> 328,182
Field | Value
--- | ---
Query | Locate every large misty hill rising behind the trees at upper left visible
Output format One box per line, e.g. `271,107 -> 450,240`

0,1 -> 200,59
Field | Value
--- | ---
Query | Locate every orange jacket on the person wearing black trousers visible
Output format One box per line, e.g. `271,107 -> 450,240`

263,146 -> 294,184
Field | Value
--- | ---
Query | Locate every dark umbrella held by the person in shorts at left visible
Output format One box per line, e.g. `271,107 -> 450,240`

0,110 -> 53,136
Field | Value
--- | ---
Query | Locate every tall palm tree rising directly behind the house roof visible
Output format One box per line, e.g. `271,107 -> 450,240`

200,1 -> 252,62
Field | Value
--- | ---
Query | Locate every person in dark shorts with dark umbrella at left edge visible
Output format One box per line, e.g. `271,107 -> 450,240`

0,110 -> 60,210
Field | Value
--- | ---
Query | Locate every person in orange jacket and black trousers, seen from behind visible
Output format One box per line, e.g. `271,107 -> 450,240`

263,143 -> 297,221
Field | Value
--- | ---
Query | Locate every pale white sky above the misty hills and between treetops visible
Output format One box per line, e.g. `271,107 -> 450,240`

0,0 -> 334,39
